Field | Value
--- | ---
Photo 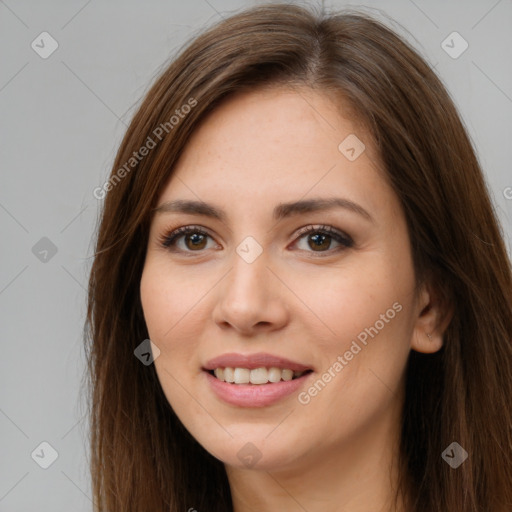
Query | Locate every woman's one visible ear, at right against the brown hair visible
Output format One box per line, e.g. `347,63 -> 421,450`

411,283 -> 453,354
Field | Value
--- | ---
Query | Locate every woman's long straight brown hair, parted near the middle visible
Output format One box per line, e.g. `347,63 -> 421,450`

86,4 -> 512,512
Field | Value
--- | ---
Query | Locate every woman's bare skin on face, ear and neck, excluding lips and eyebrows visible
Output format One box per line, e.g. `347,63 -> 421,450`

140,88 -> 442,512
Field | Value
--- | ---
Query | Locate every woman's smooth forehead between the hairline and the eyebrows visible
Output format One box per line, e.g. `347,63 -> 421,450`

162,88 -> 393,219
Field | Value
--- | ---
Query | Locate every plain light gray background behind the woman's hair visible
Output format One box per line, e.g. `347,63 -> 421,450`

0,0 -> 512,512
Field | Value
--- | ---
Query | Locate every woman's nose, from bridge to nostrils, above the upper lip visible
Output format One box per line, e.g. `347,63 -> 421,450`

213,249 -> 289,335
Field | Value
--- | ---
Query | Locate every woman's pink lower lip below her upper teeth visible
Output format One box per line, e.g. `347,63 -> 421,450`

205,371 -> 312,407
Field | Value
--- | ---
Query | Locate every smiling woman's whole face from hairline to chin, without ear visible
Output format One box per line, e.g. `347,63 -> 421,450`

141,89 -> 432,469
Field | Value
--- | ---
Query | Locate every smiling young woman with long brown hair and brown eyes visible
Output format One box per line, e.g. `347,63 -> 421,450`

87,5 -> 512,512
